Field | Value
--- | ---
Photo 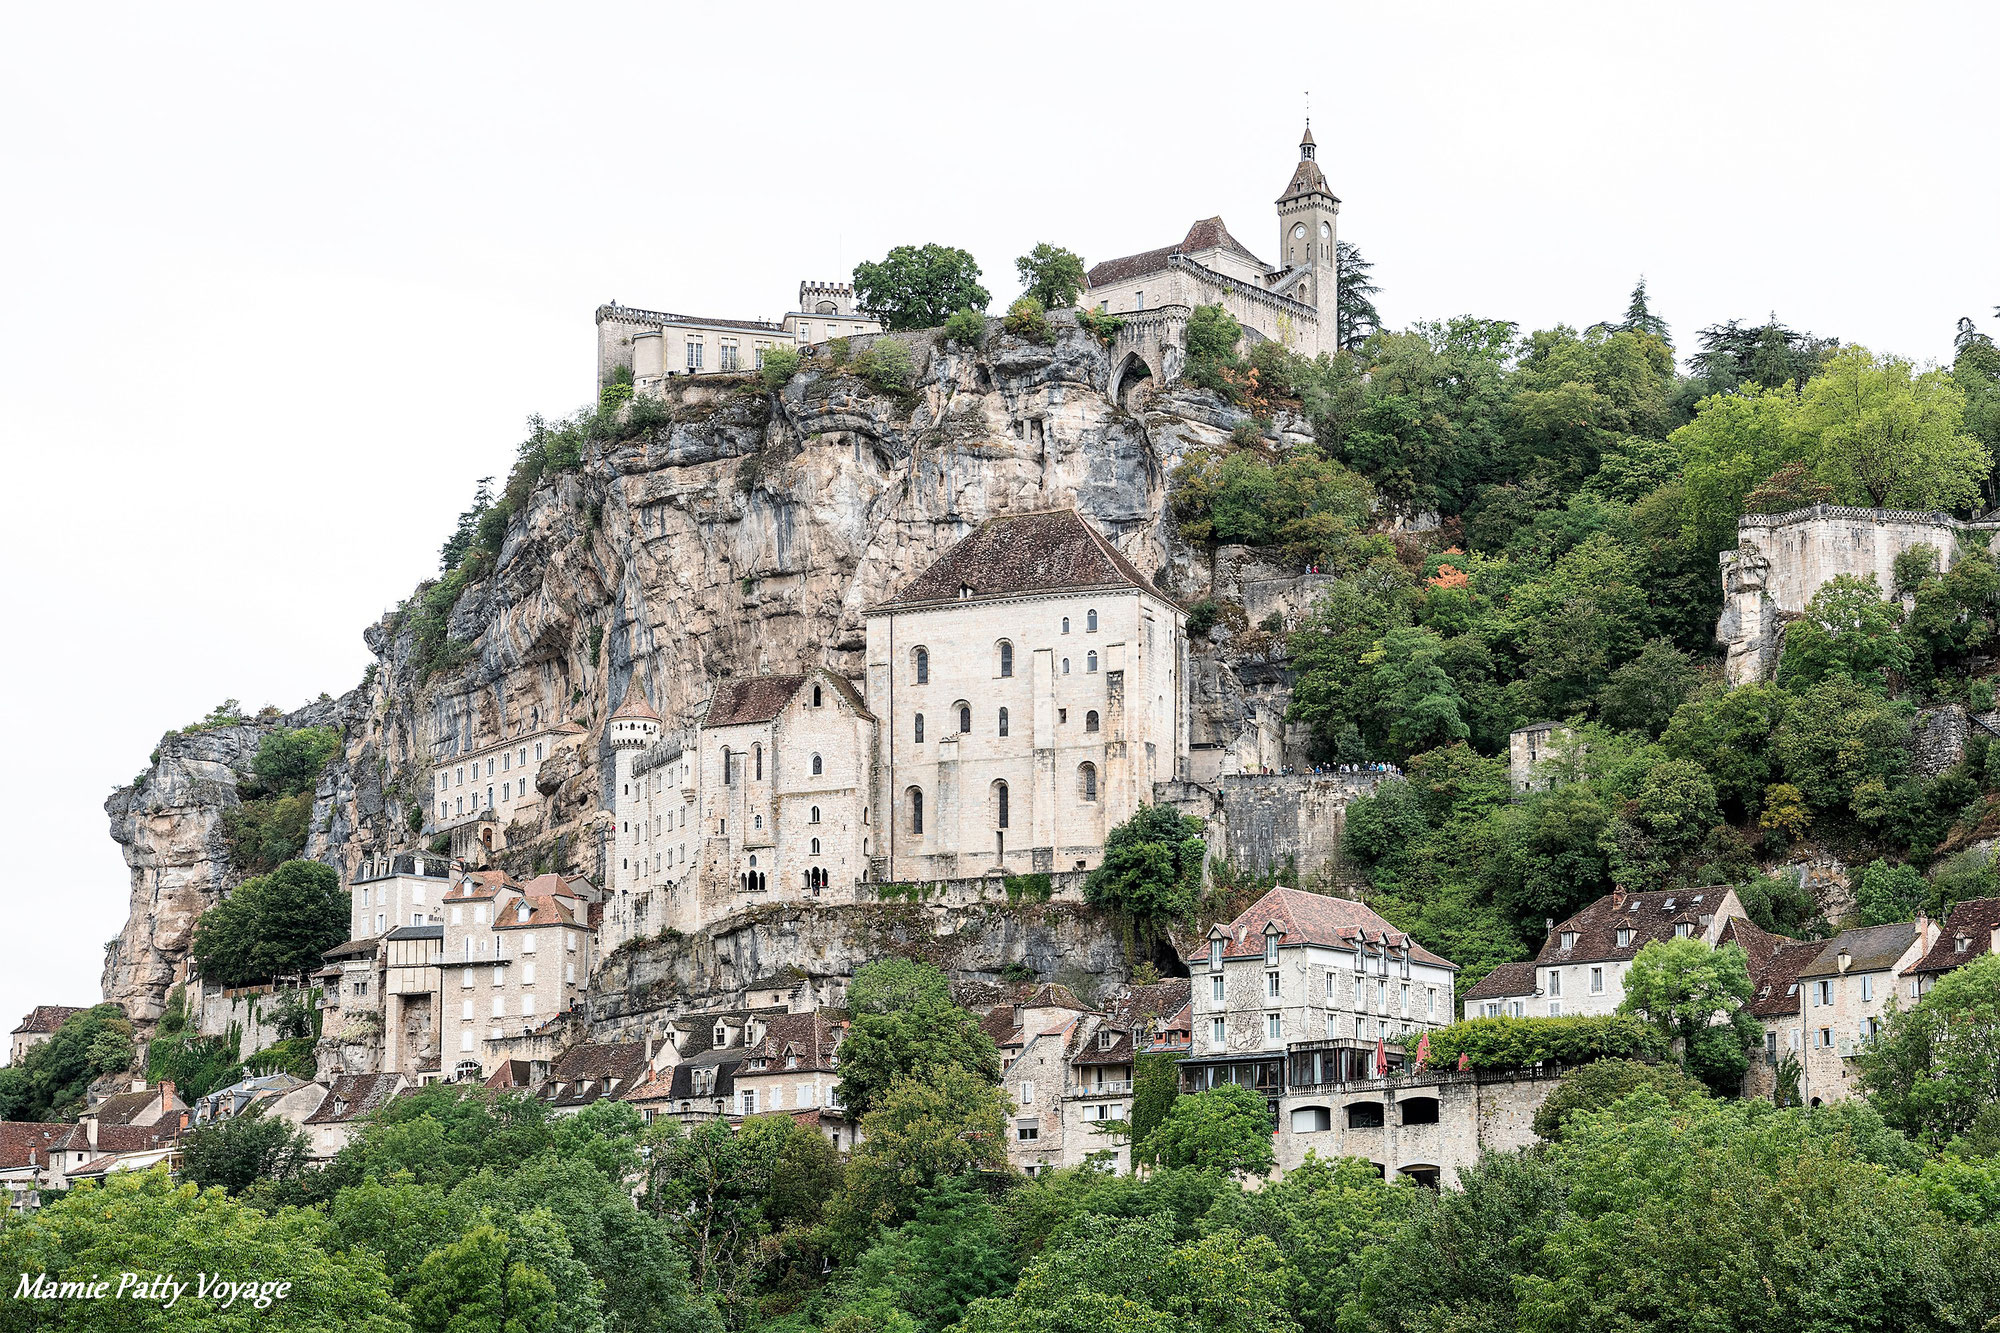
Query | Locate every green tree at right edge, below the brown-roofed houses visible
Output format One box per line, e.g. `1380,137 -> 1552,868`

1860,955 -> 2000,1151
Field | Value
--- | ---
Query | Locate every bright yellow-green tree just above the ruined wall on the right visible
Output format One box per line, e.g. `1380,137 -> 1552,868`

1798,344 -> 1992,508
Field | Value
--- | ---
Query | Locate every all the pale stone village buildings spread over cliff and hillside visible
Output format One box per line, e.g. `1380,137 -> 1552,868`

15,130 -> 2000,1207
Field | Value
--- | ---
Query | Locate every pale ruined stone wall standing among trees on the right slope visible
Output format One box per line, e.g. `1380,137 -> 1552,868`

1716,504 -> 2000,685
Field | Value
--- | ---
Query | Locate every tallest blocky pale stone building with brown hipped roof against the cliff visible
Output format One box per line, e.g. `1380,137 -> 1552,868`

866,510 -> 1188,881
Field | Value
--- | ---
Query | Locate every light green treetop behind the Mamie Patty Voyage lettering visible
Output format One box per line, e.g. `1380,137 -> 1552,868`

0,1169 -> 410,1333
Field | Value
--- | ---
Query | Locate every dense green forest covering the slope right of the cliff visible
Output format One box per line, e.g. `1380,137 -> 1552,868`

1174,296 -> 2000,987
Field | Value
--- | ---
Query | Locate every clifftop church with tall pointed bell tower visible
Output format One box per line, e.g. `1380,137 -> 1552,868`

1084,122 -> 1340,396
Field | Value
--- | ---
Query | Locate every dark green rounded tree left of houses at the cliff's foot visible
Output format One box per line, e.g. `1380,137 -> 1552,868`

192,861 -> 350,987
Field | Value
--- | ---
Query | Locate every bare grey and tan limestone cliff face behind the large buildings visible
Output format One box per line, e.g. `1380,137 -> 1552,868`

106,316 -> 1282,1019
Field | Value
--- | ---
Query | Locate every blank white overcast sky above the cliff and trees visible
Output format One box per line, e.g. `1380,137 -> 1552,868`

0,0 -> 2000,1031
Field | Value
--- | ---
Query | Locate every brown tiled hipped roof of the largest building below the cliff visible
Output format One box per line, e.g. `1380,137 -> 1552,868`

876,508 -> 1160,610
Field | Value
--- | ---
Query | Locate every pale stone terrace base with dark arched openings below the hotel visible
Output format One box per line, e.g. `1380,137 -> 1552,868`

1276,1071 -> 1558,1185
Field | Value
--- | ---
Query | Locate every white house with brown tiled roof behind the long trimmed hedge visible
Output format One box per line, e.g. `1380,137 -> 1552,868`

1526,885 -> 1748,1019
